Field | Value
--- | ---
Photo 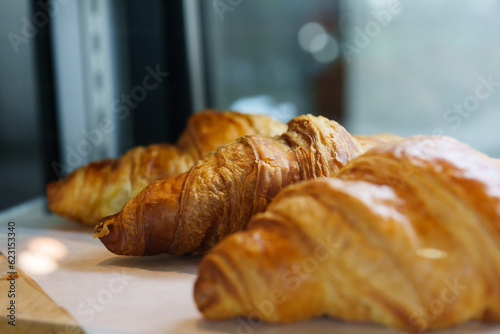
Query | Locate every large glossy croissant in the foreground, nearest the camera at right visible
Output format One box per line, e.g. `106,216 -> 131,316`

194,136 -> 500,333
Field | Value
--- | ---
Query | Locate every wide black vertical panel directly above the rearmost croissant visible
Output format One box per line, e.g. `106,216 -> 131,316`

127,0 -> 191,145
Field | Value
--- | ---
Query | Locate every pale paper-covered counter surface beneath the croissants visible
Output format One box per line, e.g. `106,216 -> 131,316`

0,198 -> 500,334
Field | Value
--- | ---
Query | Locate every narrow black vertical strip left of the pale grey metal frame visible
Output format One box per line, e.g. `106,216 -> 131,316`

30,0 -> 61,184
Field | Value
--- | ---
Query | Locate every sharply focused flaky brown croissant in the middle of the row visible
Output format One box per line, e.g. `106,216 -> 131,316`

95,115 -> 382,255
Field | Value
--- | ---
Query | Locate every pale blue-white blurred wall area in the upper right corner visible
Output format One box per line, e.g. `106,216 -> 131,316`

343,0 -> 500,157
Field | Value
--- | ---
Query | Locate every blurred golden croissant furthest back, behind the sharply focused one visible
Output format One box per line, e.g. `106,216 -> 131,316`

47,110 -> 286,226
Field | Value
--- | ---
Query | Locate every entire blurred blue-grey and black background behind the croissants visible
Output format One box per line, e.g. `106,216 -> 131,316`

0,0 -> 500,209
